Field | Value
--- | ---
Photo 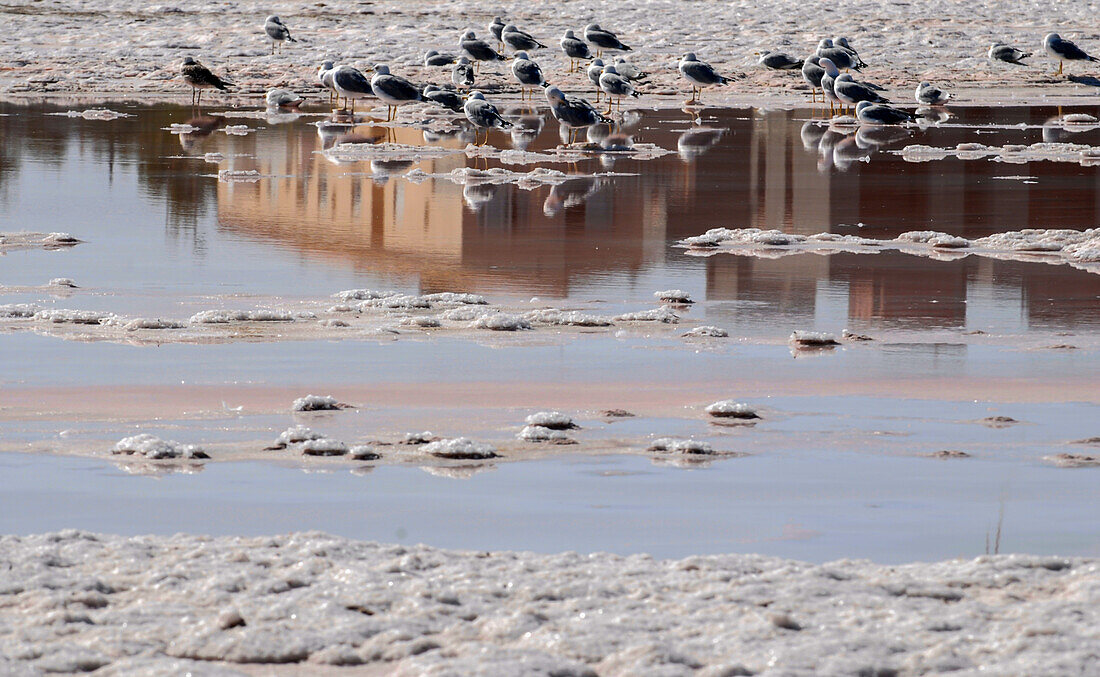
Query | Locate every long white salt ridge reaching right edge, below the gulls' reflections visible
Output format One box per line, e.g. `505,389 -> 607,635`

680,228 -> 1100,273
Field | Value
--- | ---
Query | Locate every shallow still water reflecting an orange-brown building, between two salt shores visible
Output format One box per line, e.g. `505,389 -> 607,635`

0,103 -> 1100,561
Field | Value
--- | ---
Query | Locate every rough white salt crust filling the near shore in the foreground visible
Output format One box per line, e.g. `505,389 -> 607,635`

0,531 -> 1100,676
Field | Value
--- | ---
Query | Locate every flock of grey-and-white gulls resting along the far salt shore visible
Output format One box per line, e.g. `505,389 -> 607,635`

182,15 -> 1100,143
